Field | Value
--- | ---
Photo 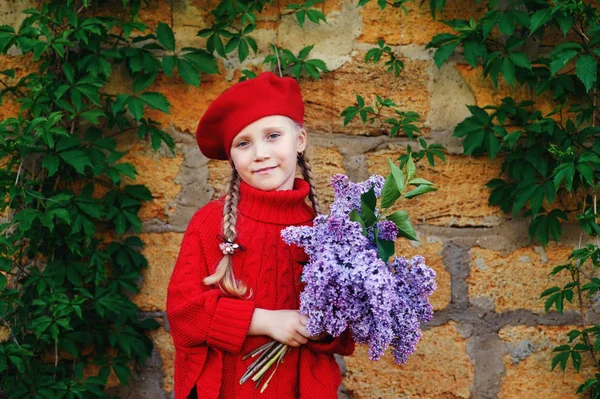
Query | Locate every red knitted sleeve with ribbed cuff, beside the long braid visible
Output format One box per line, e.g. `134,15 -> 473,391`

167,209 -> 255,353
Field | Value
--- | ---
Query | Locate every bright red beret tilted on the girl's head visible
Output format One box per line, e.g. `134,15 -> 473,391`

196,72 -> 304,160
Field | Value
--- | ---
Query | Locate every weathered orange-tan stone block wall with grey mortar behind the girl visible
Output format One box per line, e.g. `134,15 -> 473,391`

0,0 -> 585,399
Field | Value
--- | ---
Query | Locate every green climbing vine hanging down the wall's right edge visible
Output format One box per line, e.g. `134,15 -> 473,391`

427,0 -> 600,398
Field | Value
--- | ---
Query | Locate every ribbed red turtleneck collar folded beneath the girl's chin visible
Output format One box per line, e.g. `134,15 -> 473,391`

238,178 -> 315,224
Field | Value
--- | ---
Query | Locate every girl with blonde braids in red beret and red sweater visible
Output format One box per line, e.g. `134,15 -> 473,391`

167,72 -> 354,399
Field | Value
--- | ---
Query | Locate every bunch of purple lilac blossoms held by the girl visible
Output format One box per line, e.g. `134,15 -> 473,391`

282,175 -> 436,364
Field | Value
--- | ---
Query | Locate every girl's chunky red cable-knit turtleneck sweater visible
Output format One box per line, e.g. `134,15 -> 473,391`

167,179 -> 354,399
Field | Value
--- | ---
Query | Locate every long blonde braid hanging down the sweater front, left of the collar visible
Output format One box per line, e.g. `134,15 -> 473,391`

204,168 -> 248,297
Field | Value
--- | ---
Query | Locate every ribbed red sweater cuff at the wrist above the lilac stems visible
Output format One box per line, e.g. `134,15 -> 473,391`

206,298 -> 256,353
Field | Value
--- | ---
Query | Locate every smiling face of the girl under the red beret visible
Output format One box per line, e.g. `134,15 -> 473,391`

230,115 -> 306,191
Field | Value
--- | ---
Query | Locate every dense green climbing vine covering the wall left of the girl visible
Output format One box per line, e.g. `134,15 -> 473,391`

0,0 -> 218,398
